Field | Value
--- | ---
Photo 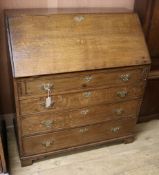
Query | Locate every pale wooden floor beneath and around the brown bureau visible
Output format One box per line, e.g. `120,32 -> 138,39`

8,120 -> 159,175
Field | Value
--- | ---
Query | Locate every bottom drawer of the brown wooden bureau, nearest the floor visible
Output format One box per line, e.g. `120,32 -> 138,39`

23,118 -> 136,156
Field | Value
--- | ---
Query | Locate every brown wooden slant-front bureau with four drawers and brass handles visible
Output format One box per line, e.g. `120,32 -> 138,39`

6,10 -> 150,166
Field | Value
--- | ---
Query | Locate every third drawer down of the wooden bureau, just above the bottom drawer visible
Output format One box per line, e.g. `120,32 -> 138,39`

21,100 -> 141,136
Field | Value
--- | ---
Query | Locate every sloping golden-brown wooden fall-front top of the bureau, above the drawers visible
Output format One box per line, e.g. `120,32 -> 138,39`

7,9 -> 150,77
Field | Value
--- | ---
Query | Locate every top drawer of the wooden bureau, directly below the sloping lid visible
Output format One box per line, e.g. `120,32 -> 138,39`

17,67 -> 144,97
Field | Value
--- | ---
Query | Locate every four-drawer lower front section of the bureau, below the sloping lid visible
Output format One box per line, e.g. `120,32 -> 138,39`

15,66 -> 149,165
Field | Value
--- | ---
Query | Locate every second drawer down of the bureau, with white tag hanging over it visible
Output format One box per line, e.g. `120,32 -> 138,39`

19,83 -> 144,115
